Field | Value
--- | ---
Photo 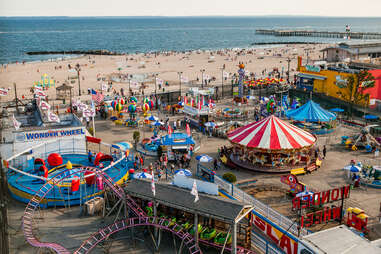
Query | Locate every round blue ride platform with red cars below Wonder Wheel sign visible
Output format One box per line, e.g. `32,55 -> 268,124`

8,153 -> 132,207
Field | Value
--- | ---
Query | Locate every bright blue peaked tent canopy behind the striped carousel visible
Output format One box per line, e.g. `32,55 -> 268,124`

286,100 -> 336,122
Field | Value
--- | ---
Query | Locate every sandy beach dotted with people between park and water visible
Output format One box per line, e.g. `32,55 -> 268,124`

0,44 -> 327,101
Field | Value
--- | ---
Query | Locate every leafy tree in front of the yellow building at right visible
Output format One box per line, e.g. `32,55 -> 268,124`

338,71 -> 374,116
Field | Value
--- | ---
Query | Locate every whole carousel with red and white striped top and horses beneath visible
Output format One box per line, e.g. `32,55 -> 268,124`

224,115 -> 318,173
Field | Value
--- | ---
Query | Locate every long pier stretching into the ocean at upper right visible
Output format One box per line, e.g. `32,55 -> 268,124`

255,29 -> 381,40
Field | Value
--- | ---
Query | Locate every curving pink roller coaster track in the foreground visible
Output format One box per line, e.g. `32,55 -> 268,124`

22,167 -> 255,254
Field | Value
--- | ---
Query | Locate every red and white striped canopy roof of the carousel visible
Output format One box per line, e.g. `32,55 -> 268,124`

228,115 -> 316,150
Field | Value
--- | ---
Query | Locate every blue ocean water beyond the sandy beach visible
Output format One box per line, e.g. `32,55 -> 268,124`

0,17 -> 381,63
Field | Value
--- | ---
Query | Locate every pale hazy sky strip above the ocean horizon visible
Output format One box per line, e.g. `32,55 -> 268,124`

0,0 -> 381,16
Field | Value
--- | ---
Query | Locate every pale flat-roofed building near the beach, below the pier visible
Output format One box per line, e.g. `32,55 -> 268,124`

321,41 -> 381,62
